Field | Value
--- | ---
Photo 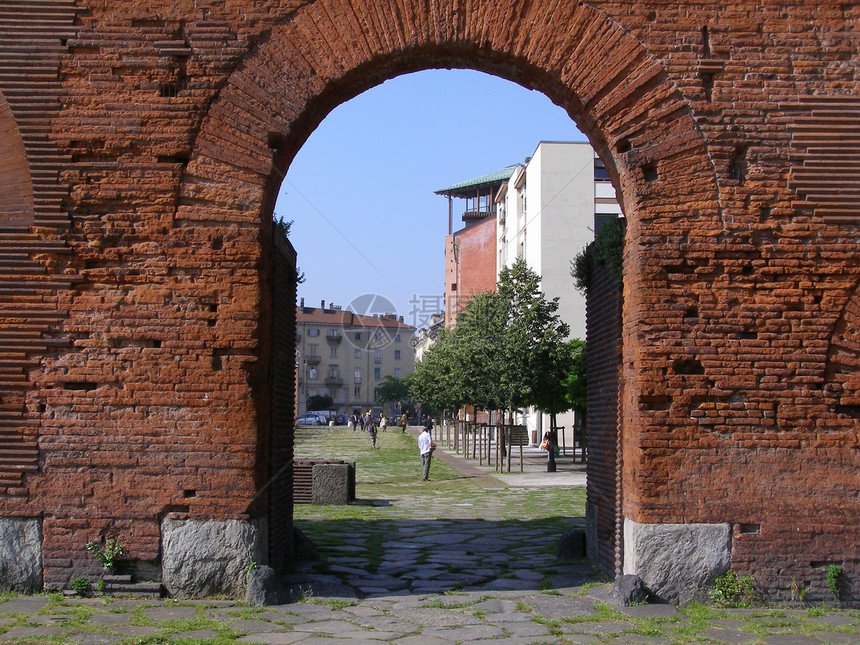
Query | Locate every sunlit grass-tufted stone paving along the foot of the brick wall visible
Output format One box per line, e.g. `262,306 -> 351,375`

0,585 -> 860,645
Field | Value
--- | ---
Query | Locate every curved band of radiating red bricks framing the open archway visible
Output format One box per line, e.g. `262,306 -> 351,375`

175,0 -> 723,569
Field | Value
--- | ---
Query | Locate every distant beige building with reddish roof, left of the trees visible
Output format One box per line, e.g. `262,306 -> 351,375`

296,303 -> 415,414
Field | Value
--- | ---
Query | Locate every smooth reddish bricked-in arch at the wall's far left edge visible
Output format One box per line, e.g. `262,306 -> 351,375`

0,94 -> 33,227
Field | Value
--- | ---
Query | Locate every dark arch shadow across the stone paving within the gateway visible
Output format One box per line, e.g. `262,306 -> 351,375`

286,517 -> 604,598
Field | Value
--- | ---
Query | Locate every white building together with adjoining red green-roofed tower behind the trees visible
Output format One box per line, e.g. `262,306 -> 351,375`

436,141 -> 623,446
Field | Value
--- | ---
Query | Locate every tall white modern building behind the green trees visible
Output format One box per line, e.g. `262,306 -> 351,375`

496,141 -> 622,446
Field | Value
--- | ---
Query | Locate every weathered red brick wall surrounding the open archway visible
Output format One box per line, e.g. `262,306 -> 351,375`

0,0 -> 860,589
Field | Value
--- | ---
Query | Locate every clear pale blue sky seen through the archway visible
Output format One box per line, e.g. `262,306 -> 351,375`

275,70 -> 585,327
